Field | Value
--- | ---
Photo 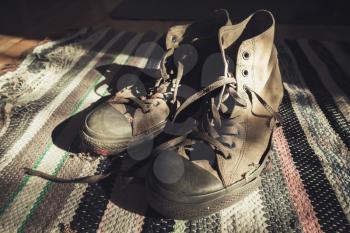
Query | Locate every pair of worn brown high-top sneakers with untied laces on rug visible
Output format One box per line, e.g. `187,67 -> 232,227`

27,10 -> 283,219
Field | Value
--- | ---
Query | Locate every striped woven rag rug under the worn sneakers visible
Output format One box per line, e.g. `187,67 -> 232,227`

0,28 -> 350,233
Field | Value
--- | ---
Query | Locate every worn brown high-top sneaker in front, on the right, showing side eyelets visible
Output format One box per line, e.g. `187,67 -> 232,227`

147,10 -> 283,219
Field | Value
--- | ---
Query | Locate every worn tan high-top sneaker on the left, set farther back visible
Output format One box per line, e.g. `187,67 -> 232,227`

81,10 -> 231,155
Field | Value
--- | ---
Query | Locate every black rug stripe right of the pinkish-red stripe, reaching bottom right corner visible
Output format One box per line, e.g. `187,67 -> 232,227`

279,91 -> 350,232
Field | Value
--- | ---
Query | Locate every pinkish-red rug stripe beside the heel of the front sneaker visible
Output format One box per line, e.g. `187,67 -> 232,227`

272,127 -> 323,233
